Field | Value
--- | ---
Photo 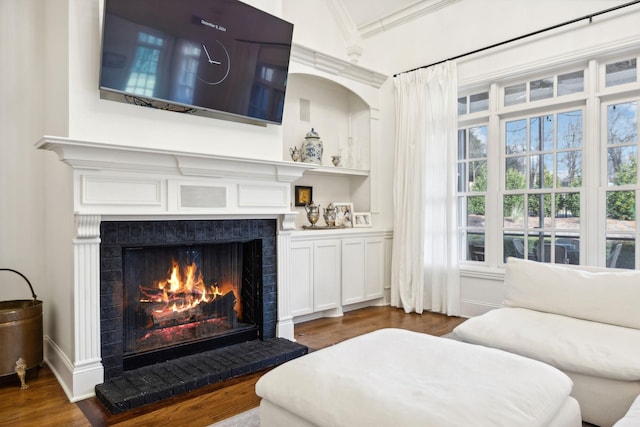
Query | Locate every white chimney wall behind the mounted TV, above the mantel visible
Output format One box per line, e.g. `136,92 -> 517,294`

58,0 -> 282,160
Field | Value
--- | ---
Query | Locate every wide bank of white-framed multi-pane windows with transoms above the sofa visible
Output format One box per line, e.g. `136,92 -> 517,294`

457,51 -> 640,269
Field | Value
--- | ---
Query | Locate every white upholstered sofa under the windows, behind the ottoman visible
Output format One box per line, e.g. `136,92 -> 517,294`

454,258 -> 640,427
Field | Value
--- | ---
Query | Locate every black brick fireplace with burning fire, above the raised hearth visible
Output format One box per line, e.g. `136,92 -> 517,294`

100,219 -> 277,380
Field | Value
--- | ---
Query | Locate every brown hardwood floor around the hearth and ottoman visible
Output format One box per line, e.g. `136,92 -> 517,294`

0,307 -> 464,427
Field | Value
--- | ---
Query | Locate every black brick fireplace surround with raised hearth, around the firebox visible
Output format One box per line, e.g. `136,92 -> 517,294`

96,219 -> 307,413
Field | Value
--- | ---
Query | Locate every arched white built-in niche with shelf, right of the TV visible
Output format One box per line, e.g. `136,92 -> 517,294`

282,67 -> 377,228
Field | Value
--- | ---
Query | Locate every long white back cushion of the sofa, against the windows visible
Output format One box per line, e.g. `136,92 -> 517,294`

503,258 -> 640,329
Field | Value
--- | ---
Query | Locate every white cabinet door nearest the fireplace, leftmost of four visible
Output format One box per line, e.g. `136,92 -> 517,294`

290,242 -> 313,317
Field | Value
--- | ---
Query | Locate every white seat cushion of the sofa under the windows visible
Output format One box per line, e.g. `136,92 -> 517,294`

454,307 -> 640,381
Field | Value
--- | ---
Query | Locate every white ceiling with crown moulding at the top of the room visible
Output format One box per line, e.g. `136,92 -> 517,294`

333,0 -> 460,37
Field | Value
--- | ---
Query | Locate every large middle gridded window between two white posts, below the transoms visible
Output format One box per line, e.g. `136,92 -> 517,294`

502,110 -> 582,264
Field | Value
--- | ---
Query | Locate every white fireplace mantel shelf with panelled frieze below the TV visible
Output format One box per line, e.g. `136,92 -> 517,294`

36,136 -> 317,216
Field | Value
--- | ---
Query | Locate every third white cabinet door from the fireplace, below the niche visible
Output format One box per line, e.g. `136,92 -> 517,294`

342,239 -> 366,305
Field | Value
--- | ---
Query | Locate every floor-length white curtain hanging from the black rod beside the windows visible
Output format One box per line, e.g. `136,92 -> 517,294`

391,62 -> 460,315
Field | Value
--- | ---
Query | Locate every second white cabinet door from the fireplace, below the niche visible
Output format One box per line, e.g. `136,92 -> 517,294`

313,240 -> 340,311
